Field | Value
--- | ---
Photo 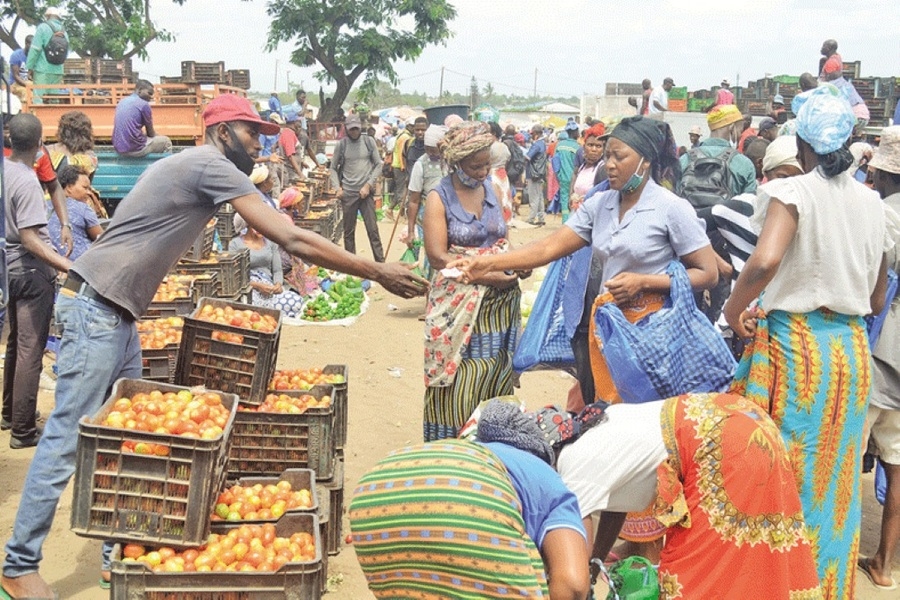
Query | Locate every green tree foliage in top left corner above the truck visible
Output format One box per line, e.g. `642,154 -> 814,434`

0,0 -> 186,60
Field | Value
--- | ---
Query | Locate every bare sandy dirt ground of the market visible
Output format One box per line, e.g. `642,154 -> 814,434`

0,214 -> 900,600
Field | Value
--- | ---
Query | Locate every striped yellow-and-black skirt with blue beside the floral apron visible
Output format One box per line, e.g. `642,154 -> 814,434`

423,286 -> 522,442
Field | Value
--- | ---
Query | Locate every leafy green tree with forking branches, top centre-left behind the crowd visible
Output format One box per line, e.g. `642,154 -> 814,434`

266,0 -> 456,120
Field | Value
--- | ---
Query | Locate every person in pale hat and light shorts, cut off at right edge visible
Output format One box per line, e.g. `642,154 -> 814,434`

859,125 -> 900,590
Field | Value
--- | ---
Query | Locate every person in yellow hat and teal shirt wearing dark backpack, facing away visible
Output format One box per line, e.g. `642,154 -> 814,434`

676,104 -> 756,323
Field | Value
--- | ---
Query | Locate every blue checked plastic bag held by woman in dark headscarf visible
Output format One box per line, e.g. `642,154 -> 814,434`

594,261 -> 737,402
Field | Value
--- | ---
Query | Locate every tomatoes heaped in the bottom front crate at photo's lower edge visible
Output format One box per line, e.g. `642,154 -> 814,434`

122,523 -> 316,573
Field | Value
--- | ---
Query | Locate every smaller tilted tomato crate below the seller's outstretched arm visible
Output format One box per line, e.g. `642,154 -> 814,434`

175,298 -> 281,406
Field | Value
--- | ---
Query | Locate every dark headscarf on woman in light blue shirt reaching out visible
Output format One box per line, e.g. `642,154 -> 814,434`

609,116 -> 681,189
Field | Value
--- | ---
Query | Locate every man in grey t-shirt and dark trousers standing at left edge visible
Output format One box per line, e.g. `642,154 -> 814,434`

3,113 -> 72,450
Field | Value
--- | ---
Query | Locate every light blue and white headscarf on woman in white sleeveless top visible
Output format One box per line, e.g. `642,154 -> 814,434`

791,85 -> 856,156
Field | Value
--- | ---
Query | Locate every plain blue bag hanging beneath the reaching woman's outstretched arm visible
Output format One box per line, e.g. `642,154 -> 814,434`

513,249 -> 589,373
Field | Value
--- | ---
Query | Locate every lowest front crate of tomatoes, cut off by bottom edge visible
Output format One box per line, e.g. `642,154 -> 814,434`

110,513 -> 325,600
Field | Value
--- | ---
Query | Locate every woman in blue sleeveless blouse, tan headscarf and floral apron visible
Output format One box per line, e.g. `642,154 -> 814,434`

423,122 -> 521,441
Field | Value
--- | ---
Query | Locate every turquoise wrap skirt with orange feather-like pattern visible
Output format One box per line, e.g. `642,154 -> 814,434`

733,309 -> 872,599
